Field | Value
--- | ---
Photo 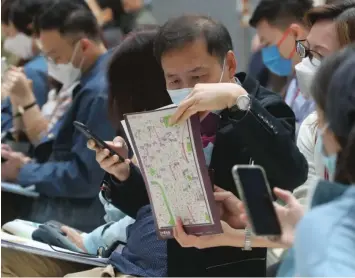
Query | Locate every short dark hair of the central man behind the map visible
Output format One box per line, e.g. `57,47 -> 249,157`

154,15 -> 233,63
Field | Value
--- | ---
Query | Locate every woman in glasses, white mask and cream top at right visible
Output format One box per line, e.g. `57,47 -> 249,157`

294,0 -> 355,202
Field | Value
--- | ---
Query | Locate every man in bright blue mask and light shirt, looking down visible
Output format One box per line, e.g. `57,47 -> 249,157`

249,0 -> 314,134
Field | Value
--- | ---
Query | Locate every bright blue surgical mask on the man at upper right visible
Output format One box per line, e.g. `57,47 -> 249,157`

261,45 -> 292,76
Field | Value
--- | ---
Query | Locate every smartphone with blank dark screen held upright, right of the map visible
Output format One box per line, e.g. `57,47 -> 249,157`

232,165 -> 281,236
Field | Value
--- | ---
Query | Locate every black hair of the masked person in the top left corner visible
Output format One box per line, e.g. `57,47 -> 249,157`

9,0 -> 52,36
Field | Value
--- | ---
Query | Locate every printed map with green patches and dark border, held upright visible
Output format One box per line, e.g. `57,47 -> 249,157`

125,108 -> 222,238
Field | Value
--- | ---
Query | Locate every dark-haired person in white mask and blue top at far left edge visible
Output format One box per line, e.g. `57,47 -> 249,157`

1,0 -> 49,131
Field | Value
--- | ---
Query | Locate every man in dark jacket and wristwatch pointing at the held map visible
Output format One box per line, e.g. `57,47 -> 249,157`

89,16 -> 307,277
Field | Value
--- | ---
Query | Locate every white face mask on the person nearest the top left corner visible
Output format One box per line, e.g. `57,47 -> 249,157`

4,33 -> 34,60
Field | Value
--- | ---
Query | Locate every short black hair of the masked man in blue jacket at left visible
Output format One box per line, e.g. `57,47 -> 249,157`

34,0 -> 101,41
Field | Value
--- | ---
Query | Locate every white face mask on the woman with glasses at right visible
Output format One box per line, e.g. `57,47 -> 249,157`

295,57 -> 320,99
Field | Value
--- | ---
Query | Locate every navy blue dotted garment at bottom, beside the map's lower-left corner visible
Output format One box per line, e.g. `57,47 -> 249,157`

109,205 -> 167,277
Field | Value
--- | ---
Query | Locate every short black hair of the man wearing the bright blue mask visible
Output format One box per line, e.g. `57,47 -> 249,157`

249,0 -> 313,28
